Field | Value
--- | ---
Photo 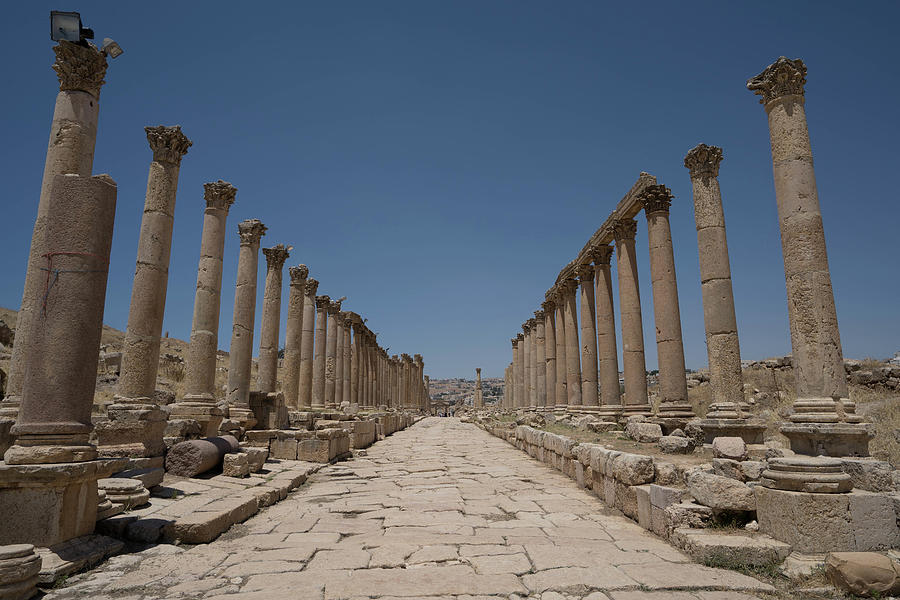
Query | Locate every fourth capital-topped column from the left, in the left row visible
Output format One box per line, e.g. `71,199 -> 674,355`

226,219 -> 266,429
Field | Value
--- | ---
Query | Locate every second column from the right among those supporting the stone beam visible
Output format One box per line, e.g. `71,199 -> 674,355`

613,219 -> 650,416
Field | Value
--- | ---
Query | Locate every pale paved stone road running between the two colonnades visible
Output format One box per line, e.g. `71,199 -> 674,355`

46,418 -> 772,600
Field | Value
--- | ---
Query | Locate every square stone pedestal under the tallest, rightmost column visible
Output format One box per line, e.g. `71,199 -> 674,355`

781,423 -> 875,456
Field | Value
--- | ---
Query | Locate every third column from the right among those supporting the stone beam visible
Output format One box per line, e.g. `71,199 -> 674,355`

592,246 -> 622,417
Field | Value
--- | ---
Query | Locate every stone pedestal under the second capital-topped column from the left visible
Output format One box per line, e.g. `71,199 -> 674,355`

94,398 -> 168,458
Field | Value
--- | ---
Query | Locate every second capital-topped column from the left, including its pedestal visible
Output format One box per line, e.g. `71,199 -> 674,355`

97,125 -> 191,460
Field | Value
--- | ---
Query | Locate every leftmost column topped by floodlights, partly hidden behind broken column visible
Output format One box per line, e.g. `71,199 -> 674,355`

0,41 -> 108,420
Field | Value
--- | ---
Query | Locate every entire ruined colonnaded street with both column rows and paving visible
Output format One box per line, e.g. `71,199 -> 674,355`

0,9 -> 900,600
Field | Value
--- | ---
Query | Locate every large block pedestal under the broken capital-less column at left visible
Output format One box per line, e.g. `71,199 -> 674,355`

0,458 -> 127,546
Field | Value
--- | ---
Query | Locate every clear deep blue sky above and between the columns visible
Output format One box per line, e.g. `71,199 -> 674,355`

0,0 -> 900,377
